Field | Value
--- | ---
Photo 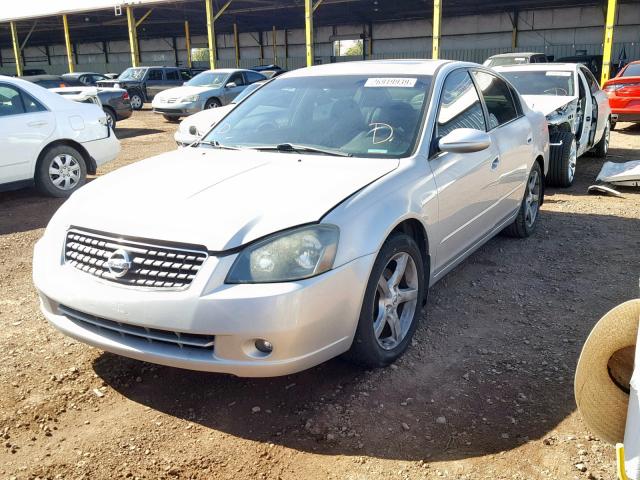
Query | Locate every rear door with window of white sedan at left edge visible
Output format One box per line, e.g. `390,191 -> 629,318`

0,82 -> 55,183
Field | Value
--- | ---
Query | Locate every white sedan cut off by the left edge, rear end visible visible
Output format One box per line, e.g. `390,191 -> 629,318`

0,76 -> 120,197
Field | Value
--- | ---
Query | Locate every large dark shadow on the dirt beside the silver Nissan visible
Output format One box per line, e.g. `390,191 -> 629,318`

93,210 -> 640,461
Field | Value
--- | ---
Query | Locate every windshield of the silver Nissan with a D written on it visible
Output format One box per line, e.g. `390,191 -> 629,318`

203,75 -> 431,158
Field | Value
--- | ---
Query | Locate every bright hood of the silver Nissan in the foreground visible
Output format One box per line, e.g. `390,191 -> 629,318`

61,148 -> 399,251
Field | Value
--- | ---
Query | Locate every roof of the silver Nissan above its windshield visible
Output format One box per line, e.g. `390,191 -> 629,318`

281,60 -> 452,78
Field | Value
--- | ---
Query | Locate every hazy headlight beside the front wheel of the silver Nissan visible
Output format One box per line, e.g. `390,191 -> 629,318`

226,225 -> 340,283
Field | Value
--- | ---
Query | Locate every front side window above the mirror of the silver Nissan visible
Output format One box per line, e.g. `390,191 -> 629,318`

435,70 -> 486,138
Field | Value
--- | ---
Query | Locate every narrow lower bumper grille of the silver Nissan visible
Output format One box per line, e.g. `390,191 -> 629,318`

58,305 -> 215,350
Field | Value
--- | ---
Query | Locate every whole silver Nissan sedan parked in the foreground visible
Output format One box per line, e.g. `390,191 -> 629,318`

33,60 -> 549,376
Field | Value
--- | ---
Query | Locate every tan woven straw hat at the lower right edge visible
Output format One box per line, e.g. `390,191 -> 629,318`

574,299 -> 640,444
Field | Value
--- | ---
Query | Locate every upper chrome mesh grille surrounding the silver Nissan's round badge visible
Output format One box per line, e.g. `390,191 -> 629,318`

64,229 -> 208,289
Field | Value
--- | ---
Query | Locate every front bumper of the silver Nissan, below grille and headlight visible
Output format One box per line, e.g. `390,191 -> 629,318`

33,235 -> 375,377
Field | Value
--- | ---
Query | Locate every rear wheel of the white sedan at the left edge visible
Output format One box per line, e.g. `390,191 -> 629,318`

35,145 -> 87,198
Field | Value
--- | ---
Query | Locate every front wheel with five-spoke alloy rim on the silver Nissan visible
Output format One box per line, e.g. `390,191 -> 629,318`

346,233 -> 426,368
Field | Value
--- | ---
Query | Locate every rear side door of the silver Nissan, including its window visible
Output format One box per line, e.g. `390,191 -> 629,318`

473,70 -> 533,223
